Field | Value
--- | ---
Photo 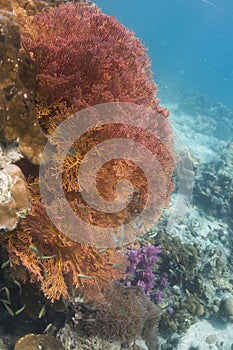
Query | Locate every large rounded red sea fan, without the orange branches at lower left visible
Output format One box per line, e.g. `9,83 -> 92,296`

18,2 -> 174,244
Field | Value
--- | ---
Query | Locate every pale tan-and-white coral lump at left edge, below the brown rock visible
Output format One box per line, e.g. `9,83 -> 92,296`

0,164 -> 30,231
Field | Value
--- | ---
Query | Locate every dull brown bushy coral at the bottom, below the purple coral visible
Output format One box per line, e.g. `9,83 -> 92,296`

58,282 -> 160,350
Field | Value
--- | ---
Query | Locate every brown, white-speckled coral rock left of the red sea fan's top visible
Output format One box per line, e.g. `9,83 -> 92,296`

0,0 -> 47,164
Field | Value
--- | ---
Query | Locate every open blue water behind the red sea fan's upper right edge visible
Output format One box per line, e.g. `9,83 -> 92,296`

96,0 -> 233,107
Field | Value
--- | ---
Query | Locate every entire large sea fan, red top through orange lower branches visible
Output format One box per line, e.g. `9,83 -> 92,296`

1,2 -> 177,300
